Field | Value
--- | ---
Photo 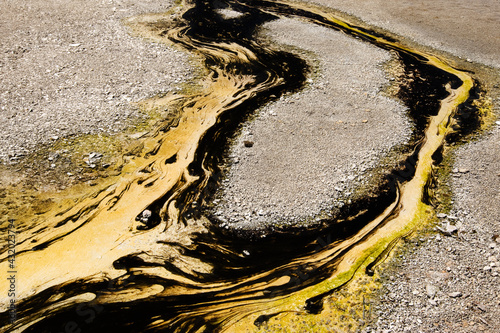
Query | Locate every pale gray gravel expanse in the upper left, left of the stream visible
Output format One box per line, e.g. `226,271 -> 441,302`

0,0 -> 190,162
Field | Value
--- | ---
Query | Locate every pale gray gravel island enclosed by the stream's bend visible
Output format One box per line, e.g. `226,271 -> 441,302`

214,19 -> 411,229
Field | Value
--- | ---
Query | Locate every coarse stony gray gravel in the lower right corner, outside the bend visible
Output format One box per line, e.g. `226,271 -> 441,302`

365,125 -> 500,333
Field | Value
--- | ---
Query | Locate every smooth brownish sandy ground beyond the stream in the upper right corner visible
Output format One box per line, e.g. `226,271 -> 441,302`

305,0 -> 500,68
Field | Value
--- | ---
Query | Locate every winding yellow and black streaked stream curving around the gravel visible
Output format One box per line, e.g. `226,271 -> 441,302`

0,0 -> 480,332
